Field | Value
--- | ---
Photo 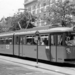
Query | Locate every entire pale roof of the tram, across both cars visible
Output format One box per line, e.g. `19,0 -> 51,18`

0,26 -> 73,36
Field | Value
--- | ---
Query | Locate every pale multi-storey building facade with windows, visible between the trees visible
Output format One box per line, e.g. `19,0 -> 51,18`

24,0 -> 74,26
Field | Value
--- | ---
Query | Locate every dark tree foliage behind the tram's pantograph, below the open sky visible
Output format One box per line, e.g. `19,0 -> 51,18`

0,12 -> 36,31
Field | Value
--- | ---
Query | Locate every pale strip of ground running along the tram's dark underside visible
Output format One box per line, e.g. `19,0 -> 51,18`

0,56 -> 75,75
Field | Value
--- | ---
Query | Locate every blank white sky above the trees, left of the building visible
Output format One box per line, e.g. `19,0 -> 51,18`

0,0 -> 24,19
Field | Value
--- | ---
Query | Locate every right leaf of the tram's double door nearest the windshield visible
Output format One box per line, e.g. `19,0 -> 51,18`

56,32 -> 66,62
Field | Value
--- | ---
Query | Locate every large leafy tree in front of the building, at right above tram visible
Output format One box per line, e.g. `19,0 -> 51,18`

42,0 -> 75,26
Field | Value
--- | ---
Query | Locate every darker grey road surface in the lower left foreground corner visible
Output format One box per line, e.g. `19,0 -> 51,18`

0,60 -> 55,75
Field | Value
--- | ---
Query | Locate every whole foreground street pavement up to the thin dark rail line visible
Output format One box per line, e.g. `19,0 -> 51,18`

0,59 -> 64,75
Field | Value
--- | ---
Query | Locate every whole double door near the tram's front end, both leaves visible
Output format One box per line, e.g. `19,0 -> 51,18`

50,33 -> 66,62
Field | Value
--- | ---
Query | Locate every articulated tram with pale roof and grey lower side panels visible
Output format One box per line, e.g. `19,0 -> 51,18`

0,26 -> 75,63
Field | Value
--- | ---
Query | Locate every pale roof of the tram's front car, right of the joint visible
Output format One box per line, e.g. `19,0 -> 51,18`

15,26 -> 73,35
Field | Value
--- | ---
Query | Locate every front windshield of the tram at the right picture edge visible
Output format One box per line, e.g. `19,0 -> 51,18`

65,33 -> 75,46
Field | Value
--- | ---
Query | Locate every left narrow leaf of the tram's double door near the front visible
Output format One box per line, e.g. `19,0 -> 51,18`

50,34 -> 57,62
